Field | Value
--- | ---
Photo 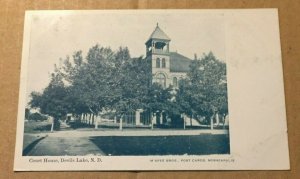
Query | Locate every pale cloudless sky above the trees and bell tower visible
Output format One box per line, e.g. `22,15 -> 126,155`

25,10 -> 225,98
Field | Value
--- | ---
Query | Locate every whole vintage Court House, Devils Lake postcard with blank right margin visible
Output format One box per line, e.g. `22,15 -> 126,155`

14,9 -> 290,171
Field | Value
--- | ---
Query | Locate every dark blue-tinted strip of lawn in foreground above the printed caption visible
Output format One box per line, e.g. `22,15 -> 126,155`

90,134 -> 230,156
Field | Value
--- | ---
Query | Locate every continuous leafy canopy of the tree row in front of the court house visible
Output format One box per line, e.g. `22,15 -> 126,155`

29,44 -> 228,129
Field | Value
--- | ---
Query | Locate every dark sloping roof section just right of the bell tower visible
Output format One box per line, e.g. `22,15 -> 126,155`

170,52 -> 192,72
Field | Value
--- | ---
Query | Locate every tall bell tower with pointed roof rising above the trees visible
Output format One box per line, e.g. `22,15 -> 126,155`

145,23 -> 171,88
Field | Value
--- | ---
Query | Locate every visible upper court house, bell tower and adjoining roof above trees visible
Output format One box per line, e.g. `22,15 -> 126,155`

145,24 -> 192,88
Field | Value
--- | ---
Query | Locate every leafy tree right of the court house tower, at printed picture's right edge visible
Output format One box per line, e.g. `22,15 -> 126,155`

176,52 -> 228,127
